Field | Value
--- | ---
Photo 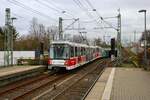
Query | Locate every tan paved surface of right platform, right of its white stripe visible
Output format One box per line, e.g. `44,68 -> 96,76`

110,68 -> 150,100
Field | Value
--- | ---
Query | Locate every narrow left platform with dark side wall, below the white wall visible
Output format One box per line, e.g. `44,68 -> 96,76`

0,65 -> 46,86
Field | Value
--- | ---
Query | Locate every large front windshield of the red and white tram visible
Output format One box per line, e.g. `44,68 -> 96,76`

50,44 -> 69,59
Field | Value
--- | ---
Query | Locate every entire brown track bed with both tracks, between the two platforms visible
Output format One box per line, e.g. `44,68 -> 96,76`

0,60 -> 109,100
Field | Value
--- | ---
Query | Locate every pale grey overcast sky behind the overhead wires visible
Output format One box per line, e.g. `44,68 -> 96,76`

0,0 -> 150,41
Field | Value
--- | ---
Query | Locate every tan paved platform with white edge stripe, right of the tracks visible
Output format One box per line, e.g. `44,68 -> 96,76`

85,68 -> 150,100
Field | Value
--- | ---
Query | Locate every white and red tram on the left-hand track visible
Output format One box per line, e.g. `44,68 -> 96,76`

48,41 -> 102,70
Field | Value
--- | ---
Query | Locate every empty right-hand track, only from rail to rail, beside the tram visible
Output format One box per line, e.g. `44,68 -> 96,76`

52,59 -> 104,100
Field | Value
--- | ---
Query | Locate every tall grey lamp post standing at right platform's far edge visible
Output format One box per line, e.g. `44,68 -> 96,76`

139,9 -> 147,65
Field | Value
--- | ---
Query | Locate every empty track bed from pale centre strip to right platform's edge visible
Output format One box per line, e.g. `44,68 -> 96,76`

34,60 -> 106,100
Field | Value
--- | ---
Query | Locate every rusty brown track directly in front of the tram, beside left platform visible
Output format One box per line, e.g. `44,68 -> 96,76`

0,72 -> 67,100
